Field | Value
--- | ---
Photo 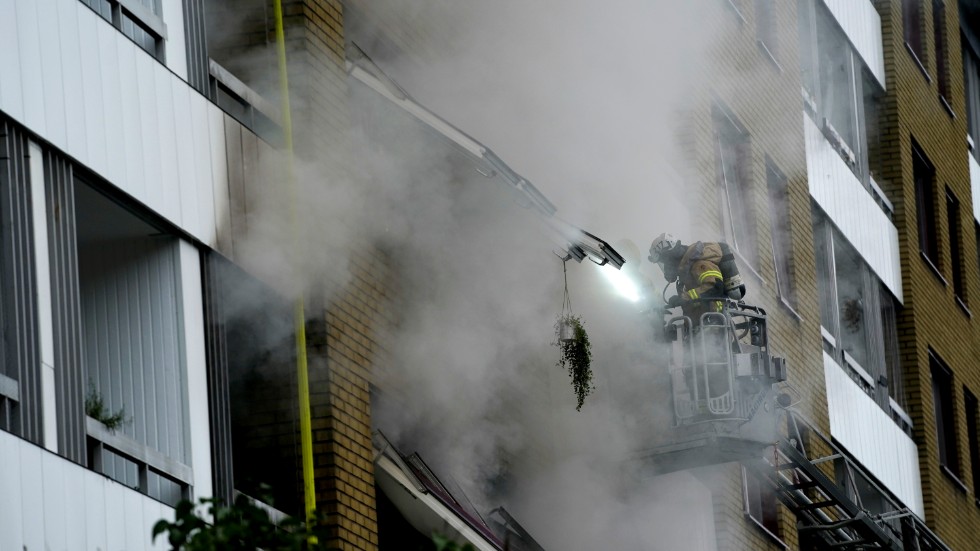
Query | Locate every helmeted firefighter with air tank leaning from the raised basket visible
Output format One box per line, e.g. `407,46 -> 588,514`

648,233 -> 732,326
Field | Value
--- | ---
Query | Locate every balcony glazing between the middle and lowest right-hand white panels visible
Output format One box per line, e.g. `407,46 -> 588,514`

813,206 -> 907,418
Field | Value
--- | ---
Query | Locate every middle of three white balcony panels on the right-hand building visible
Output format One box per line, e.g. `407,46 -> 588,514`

803,113 -> 904,302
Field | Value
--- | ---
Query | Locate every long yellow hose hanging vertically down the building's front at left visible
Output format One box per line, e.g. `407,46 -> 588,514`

273,0 -> 316,532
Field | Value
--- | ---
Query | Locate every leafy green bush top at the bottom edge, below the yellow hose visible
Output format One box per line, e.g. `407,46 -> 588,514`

153,495 -> 329,551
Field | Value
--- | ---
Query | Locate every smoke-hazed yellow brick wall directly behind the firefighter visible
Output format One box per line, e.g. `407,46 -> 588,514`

684,0 -> 829,550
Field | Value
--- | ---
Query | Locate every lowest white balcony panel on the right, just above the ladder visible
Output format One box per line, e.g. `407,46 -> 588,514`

823,353 -> 924,518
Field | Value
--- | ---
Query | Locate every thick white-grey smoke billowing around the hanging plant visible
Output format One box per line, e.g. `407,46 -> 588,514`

228,0 -> 736,549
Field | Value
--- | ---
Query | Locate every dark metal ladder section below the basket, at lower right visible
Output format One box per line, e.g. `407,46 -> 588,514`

746,410 -> 950,551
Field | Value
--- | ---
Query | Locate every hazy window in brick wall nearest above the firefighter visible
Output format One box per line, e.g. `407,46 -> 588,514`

713,106 -> 758,266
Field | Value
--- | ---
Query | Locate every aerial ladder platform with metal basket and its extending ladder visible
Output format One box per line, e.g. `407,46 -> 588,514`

637,298 -> 950,551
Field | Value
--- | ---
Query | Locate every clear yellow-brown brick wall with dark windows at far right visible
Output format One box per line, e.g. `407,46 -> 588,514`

875,0 -> 980,549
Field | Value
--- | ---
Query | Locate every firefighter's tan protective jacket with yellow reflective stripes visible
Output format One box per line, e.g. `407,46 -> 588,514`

677,241 -> 724,325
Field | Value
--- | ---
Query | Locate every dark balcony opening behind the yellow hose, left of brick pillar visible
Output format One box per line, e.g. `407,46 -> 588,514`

204,253 -> 303,515
